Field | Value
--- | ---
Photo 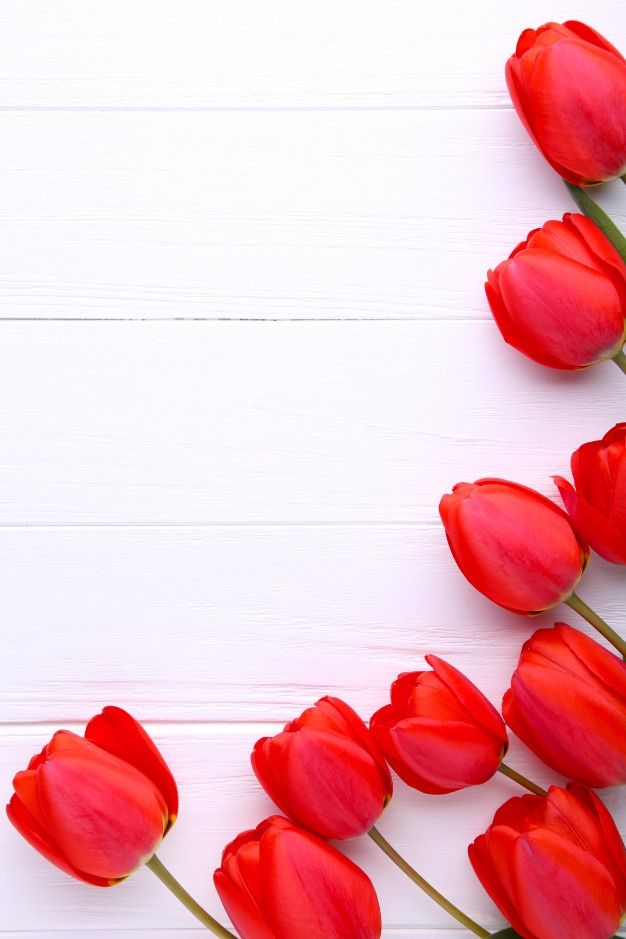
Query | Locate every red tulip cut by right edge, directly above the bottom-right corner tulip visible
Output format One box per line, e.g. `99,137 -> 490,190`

503,623 -> 626,787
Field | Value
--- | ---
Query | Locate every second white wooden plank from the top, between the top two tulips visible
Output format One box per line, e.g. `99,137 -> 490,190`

0,110 -> 626,320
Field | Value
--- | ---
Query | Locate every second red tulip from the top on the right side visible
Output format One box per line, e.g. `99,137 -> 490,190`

485,213 -> 626,371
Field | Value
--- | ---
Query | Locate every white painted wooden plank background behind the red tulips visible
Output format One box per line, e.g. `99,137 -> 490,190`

0,0 -> 626,939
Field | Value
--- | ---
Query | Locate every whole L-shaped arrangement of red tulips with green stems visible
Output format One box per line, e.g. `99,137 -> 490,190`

8,16 -> 626,939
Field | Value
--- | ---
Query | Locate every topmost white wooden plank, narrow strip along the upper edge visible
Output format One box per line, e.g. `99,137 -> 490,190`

0,0 -> 626,108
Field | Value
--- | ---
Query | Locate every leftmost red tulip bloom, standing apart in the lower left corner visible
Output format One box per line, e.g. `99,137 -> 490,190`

7,707 -> 178,887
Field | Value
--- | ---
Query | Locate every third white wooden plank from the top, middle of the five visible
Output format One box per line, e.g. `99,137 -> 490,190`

0,322 -> 624,525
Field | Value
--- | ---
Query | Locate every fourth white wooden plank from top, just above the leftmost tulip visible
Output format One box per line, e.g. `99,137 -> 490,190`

0,526 -> 626,721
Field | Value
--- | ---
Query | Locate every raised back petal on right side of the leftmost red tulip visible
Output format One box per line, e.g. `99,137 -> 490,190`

85,707 -> 178,830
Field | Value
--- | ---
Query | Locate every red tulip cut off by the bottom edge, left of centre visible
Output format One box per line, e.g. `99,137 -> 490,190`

214,816 -> 381,939
